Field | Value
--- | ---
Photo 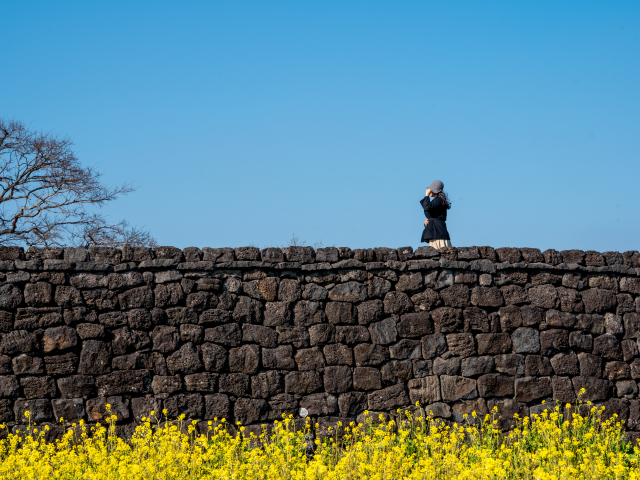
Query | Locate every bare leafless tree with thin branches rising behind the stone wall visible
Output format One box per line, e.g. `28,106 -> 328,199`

0,118 -> 155,246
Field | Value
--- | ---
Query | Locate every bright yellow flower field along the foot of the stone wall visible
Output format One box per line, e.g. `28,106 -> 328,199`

0,398 -> 640,480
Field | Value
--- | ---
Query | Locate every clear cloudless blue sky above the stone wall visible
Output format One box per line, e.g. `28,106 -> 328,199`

0,0 -> 640,251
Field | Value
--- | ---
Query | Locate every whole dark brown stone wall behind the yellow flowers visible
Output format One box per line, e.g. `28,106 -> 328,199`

0,247 -> 640,435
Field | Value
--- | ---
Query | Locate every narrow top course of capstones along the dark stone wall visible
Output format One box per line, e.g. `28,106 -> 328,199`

0,246 -> 640,276
